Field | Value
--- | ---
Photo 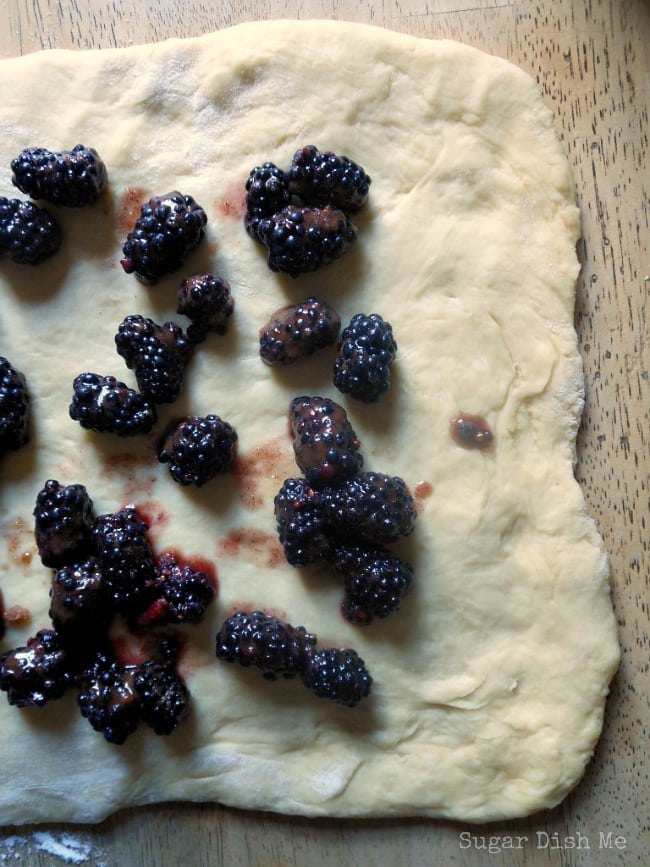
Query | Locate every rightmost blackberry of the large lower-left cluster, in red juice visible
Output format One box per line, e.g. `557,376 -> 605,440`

138,554 -> 214,626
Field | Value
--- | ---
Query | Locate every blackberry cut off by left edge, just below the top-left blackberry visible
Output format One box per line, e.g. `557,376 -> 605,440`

0,196 -> 61,265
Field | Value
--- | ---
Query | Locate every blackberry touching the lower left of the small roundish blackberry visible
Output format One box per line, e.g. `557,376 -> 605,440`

115,314 -> 192,404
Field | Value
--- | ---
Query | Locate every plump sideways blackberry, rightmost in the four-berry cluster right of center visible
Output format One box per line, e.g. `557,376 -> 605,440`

323,472 -> 416,545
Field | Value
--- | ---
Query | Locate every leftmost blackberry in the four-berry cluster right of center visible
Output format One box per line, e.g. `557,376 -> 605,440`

273,479 -> 330,566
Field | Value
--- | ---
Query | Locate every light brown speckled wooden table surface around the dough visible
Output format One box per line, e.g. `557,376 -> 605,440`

0,0 -> 650,867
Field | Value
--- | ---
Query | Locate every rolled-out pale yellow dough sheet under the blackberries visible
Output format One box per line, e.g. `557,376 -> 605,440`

0,21 -> 619,824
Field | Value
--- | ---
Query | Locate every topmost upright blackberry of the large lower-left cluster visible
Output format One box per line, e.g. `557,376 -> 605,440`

33,479 -> 94,569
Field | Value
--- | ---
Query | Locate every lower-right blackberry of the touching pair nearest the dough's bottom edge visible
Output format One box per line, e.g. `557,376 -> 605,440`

300,647 -> 372,707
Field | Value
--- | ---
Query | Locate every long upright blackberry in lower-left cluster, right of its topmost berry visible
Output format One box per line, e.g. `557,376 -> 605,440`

93,507 -> 156,613
